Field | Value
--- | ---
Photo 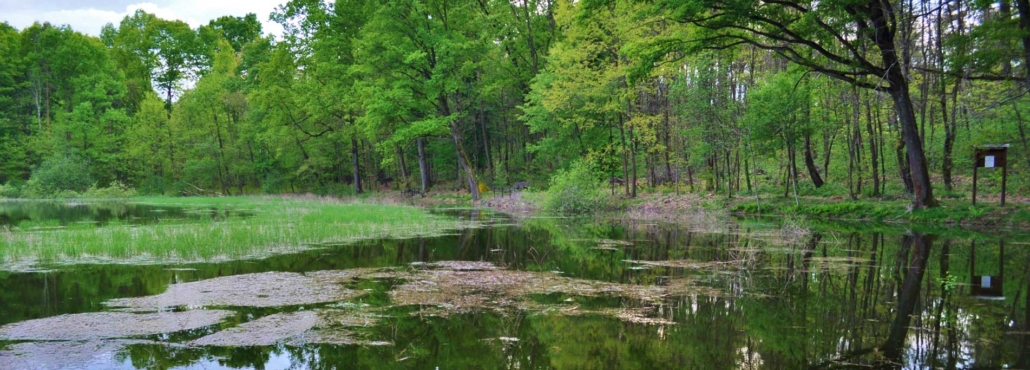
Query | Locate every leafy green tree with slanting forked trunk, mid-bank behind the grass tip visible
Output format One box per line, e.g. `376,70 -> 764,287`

356,0 -> 491,200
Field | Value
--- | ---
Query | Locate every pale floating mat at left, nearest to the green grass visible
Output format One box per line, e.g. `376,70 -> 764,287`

105,272 -> 366,311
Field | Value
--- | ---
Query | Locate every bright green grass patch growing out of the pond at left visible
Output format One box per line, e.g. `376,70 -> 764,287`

0,197 -> 469,270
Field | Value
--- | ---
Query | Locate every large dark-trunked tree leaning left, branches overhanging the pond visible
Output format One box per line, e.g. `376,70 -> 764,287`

609,0 -> 937,208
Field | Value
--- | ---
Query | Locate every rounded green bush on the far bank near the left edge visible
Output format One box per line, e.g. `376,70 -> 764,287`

22,156 -> 94,198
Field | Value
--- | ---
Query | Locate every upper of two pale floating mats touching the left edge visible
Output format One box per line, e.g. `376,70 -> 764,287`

0,309 -> 233,340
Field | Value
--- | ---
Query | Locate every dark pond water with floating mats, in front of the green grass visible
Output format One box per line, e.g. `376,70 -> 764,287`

0,200 -> 1030,369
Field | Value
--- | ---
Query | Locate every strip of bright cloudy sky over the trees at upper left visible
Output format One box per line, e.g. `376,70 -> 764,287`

0,0 -> 287,36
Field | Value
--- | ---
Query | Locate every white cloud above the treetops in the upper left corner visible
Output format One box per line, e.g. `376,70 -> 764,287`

0,0 -> 286,35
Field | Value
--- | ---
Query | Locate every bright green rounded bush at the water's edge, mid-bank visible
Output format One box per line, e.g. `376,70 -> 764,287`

544,161 -> 605,214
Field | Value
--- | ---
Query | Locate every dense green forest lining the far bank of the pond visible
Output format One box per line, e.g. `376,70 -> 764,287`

0,0 -> 1030,208
